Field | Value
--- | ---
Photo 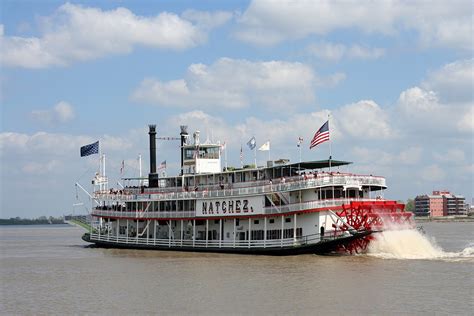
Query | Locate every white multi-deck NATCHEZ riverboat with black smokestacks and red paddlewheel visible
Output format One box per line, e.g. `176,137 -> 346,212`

83,125 -> 411,255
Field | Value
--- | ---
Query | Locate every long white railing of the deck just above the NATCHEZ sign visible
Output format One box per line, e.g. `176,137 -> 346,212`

94,174 -> 386,201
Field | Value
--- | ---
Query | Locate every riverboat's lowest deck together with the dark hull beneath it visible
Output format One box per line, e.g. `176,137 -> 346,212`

88,211 -> 366,253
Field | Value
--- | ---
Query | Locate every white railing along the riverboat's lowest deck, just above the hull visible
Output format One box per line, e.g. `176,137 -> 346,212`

90,230 -> 350,248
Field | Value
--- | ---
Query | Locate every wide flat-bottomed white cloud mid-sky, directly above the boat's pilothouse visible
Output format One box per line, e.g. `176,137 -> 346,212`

131,58 -> 320,109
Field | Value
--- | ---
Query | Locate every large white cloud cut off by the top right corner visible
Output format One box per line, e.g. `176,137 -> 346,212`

236,0 -> 473,50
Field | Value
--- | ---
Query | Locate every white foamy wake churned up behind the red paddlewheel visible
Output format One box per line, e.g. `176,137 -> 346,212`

367,229 -> 474,261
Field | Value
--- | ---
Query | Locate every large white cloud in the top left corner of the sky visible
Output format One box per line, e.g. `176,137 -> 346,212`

0,3 -> 231,68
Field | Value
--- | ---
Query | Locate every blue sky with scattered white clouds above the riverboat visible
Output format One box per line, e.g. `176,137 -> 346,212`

0,0 -> 474,218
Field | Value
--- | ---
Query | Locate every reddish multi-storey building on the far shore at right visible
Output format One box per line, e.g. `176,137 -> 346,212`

415,191 -> 467,217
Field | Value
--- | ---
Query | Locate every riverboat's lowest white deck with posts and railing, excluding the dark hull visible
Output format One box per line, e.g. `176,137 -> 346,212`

91,211 -> 337,245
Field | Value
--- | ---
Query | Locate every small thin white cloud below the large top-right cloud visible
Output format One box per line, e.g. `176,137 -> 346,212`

306,42 -> 385,61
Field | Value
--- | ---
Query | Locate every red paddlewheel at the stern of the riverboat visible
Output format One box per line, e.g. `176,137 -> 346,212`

333,200 -> 415,254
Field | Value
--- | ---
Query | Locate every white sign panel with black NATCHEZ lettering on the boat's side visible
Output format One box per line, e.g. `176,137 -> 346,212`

196,197 -> 264,217
